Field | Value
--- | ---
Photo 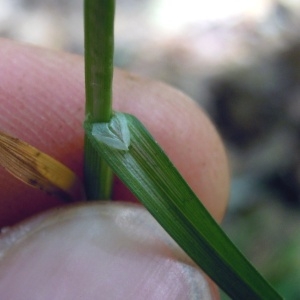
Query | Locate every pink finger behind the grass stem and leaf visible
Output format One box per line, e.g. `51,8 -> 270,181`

0,40 -> 229,299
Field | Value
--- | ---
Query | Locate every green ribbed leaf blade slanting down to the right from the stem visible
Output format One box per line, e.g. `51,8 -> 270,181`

85,113 -> 281,300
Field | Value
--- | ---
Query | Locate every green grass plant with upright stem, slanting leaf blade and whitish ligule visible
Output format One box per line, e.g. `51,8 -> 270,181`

84,0 -> 281,300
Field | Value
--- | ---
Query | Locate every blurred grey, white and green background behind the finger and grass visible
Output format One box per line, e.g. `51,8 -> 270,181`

0,0 -> 300,299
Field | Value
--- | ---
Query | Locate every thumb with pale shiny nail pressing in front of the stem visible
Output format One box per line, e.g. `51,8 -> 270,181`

0,203 -> 216,300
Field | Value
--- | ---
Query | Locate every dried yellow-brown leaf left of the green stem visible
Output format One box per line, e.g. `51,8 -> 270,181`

0,132 -> 85,201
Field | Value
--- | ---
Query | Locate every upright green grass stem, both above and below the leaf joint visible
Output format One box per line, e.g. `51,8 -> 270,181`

84,0 -> 115,199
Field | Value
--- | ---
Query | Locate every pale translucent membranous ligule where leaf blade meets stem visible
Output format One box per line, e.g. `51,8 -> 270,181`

92,113 -> 130,151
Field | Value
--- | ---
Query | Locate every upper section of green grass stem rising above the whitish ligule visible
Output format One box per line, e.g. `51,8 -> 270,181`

84,0 -> 115,122
